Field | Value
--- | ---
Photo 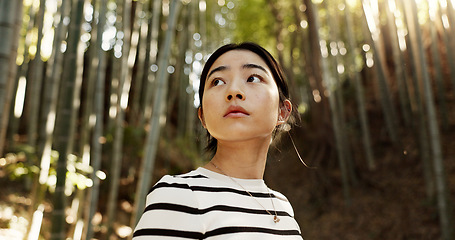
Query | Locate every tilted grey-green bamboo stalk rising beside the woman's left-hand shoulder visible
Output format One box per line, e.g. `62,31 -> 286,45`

131,0 -> 181,230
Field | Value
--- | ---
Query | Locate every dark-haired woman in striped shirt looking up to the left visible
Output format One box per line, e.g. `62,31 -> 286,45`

134,43 -> 302,240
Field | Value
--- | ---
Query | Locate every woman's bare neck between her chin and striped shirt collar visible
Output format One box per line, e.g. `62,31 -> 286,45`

204,136 -> 270,179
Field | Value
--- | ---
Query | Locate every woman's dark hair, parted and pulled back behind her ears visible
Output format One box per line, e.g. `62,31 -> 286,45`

199,42 -> 295,154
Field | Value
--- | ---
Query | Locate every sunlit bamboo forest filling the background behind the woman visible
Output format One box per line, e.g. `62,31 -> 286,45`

0,0 -> 455,240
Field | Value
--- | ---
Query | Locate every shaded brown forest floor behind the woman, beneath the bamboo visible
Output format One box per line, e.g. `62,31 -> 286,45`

0,93 -> 455,240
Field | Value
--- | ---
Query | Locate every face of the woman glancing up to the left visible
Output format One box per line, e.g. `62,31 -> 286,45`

199,50 -> 283,142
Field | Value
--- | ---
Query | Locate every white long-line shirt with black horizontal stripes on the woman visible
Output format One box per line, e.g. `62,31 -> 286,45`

133,168 -> 302,240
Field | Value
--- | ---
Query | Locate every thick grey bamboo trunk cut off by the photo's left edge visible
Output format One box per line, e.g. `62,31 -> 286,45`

0,0 -> 23,156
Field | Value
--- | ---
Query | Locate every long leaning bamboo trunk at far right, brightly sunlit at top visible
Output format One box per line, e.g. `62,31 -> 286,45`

405,0 -> 453,237
